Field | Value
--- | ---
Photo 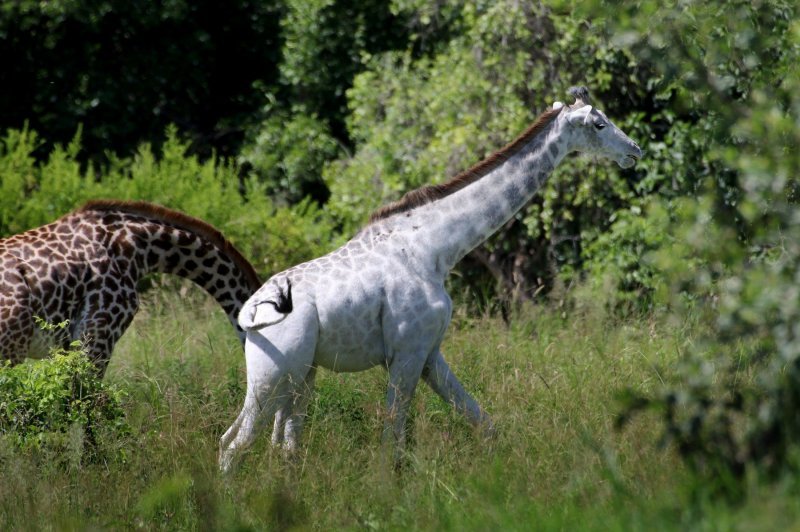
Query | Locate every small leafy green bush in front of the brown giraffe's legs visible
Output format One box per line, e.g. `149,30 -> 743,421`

0,323 -> 130,464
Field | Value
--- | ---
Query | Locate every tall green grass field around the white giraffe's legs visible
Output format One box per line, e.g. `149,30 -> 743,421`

0,287 -> 800,530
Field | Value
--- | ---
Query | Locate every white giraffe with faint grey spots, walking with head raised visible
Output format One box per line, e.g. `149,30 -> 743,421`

219,87 -> 642,471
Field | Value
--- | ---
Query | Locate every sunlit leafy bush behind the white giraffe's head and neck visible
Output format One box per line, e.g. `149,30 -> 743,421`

323,2 -> 705,299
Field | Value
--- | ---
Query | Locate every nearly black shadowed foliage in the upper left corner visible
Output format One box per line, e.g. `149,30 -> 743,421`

0,0 -> 283,160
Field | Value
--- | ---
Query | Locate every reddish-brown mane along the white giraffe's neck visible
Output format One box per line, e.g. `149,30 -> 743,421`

369,109 -> 561,223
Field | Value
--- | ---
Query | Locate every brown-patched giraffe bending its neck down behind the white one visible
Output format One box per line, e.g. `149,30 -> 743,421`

0,200 -> 261,375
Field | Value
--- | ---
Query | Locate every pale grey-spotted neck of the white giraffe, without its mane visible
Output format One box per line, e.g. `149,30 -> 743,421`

406,115 -> 568,275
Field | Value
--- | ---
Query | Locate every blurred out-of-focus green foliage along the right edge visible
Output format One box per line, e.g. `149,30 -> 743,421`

604,2 -> 800,493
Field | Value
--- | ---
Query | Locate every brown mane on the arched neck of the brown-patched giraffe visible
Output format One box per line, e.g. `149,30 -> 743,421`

75,199 -> 261,291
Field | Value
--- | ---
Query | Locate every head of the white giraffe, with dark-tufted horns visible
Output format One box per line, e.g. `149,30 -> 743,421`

553,87 -> 642,168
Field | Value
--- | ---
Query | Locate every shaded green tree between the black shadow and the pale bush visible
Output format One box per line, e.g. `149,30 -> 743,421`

240,0 -> 408,204
